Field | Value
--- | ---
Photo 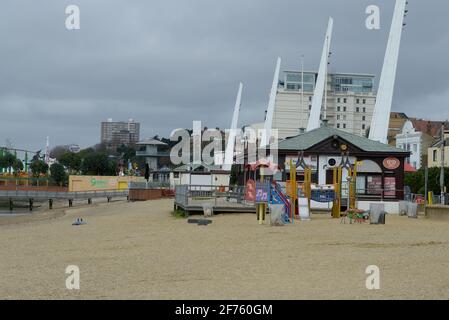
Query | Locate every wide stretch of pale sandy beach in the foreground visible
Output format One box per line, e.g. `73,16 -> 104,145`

0,199 -> 449,299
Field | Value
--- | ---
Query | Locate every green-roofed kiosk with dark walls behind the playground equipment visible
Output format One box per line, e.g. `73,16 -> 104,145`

234,127 -> 410,206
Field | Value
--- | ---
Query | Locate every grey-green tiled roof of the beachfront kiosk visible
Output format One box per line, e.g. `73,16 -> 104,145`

271,127 -> 408,153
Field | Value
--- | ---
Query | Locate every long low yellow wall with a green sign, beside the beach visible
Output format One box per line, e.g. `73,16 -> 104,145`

69,176 -> 145,191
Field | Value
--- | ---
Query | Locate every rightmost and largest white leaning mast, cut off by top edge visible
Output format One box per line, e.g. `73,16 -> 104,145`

369,0 -> 408,143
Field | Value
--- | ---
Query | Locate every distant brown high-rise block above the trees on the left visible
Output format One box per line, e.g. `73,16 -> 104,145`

101,119 -> 140,149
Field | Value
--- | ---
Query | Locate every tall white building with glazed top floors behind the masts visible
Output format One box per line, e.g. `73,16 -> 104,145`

273,71 -> 376,139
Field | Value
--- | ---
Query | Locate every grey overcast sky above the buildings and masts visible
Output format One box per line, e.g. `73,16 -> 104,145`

0,0 -> 449,150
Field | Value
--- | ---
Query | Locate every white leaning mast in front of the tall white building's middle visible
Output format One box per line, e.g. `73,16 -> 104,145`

307,17 -> 334,131
